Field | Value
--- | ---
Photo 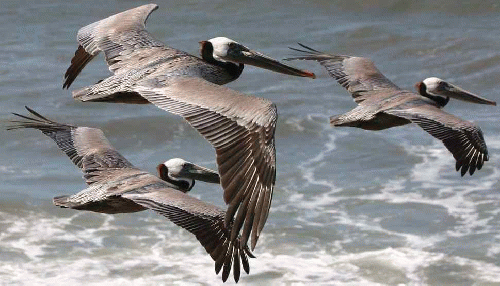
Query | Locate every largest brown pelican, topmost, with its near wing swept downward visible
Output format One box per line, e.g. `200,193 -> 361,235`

63,4 -> 315,250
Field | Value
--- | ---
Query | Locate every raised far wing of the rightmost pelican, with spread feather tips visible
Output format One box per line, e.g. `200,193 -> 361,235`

286,43 -> 401,104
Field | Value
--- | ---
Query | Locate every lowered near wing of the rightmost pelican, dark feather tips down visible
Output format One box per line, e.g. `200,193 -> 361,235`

385,105 -> 489,176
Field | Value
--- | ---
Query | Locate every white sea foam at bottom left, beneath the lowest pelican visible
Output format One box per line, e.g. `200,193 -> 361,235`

0,212 -> 235,285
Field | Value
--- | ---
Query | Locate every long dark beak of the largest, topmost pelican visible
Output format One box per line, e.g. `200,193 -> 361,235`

225,46 -> 316,78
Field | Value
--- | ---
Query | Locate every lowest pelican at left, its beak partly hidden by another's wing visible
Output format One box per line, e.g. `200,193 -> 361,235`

9,107 -> 254,282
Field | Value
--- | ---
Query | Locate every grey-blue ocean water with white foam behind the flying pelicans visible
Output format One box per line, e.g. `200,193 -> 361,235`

0,0 -> 500,285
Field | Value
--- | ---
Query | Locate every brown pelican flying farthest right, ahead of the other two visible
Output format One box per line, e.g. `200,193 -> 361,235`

288,43 -> 496,176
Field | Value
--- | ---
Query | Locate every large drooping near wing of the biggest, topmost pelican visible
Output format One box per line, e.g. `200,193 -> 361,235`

134,78 -> 277,249
